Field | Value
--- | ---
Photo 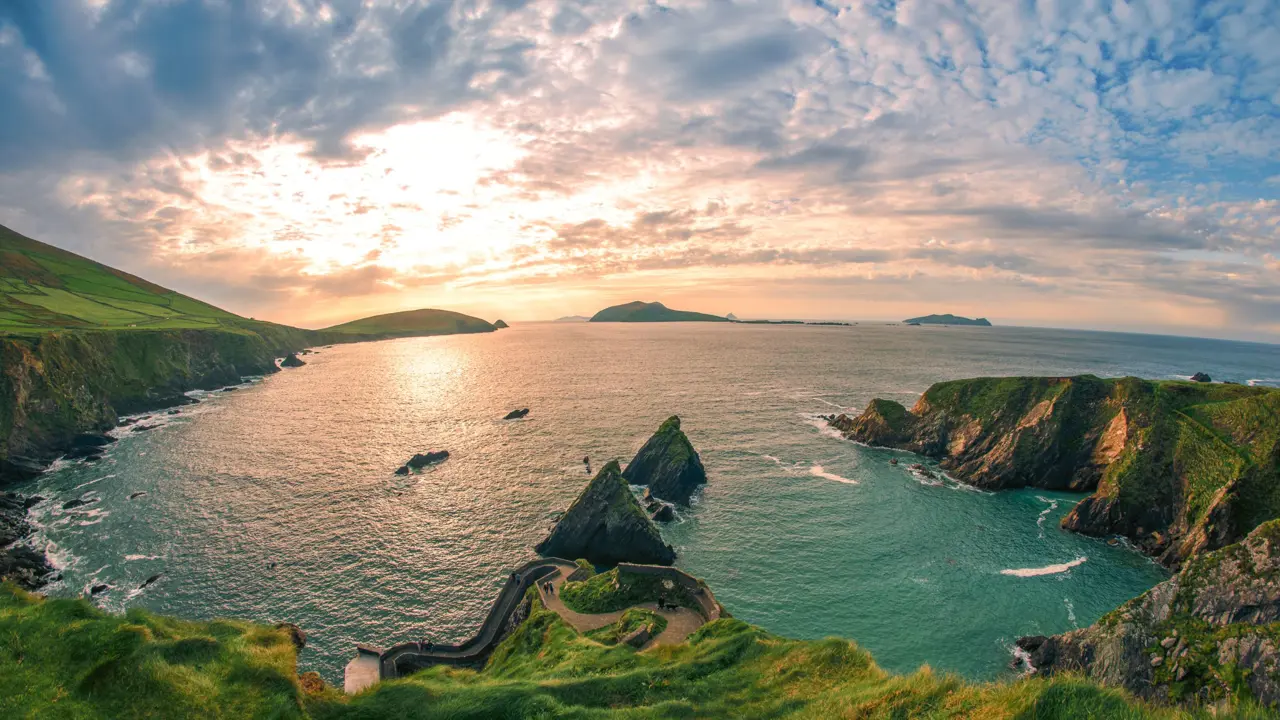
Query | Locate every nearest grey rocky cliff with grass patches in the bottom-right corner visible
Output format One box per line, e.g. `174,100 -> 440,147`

1018,520 -> 1280,706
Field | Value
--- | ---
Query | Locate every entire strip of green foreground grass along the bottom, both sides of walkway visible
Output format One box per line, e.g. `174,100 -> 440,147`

0,585 -> 1267,719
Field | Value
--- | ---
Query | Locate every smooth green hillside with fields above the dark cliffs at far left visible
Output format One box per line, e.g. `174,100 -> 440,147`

0,225 -> 259,334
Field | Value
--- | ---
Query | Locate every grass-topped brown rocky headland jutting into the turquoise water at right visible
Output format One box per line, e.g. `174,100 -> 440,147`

831,375 -> 1280,566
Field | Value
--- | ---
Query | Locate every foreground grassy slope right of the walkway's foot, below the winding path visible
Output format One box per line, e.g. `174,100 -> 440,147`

308,589 -> 1265,719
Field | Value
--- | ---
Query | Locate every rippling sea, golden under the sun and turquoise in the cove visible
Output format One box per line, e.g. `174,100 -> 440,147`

17,324 -> 1280,680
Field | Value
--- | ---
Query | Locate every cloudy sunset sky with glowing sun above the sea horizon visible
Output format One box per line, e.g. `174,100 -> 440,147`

0,0 -> 1280,341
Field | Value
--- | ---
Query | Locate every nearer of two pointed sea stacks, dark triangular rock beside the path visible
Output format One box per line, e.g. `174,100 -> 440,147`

534,460 -> 676,565
